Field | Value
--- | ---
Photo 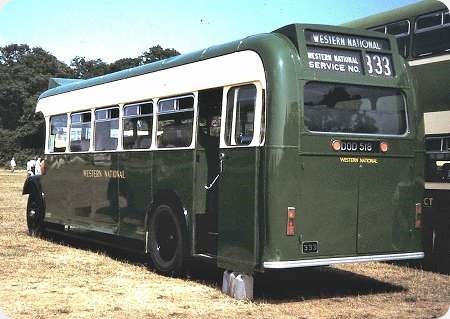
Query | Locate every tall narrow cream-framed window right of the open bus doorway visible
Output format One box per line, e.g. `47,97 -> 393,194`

225,84 -> 256,146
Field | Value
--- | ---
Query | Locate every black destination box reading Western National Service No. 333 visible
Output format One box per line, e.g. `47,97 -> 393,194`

305,30 -> 395,77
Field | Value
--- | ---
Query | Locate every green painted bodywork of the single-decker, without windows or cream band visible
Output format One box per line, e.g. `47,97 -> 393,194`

40,25 -> 423,272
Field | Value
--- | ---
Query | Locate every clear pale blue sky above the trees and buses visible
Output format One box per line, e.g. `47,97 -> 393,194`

0,0 -> 436,63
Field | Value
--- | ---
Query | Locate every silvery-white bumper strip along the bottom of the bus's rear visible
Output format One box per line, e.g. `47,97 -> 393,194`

264,252 -> 424,269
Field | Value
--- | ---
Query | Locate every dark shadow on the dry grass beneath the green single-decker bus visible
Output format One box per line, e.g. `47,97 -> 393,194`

40,234 -> 406,304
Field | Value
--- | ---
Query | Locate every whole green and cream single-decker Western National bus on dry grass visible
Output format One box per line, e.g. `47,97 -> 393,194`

24,24 -> 424,286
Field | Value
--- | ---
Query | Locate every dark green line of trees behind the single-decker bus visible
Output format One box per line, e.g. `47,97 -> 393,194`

0,44 -> 180,167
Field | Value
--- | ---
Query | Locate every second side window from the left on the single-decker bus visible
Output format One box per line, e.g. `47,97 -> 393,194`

70,112 -> 91,152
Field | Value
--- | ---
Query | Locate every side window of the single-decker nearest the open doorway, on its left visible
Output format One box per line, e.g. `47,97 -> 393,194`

156,96 -> 194,148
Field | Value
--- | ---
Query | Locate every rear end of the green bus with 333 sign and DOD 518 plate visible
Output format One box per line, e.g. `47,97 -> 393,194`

263,25 -> 423,269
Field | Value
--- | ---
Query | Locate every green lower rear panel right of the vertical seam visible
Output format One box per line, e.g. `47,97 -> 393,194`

357,157 -> 420,254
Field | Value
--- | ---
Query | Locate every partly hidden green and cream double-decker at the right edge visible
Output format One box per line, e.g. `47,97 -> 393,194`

345,1 -> 450,272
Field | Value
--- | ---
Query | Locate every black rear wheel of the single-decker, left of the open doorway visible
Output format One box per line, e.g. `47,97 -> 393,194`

148,204 -> 186,276
